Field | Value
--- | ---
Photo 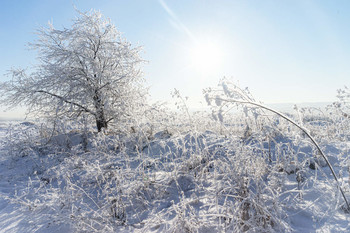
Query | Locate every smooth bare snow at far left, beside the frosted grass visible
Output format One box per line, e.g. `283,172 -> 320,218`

0,120 -> 69,233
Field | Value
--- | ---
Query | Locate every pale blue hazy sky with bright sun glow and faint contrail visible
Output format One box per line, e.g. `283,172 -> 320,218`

0,0 -> 350,114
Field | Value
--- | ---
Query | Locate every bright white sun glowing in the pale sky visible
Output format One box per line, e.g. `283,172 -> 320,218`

189,40 -> 223,74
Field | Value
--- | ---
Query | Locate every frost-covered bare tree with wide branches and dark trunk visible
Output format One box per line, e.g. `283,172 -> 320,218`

0,11 -> 146,131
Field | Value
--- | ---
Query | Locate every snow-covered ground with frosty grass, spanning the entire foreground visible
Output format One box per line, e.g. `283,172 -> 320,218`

0,116 -> 350,233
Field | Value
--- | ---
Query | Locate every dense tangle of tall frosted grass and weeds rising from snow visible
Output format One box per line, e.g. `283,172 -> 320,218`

2,81 -> 350,232
